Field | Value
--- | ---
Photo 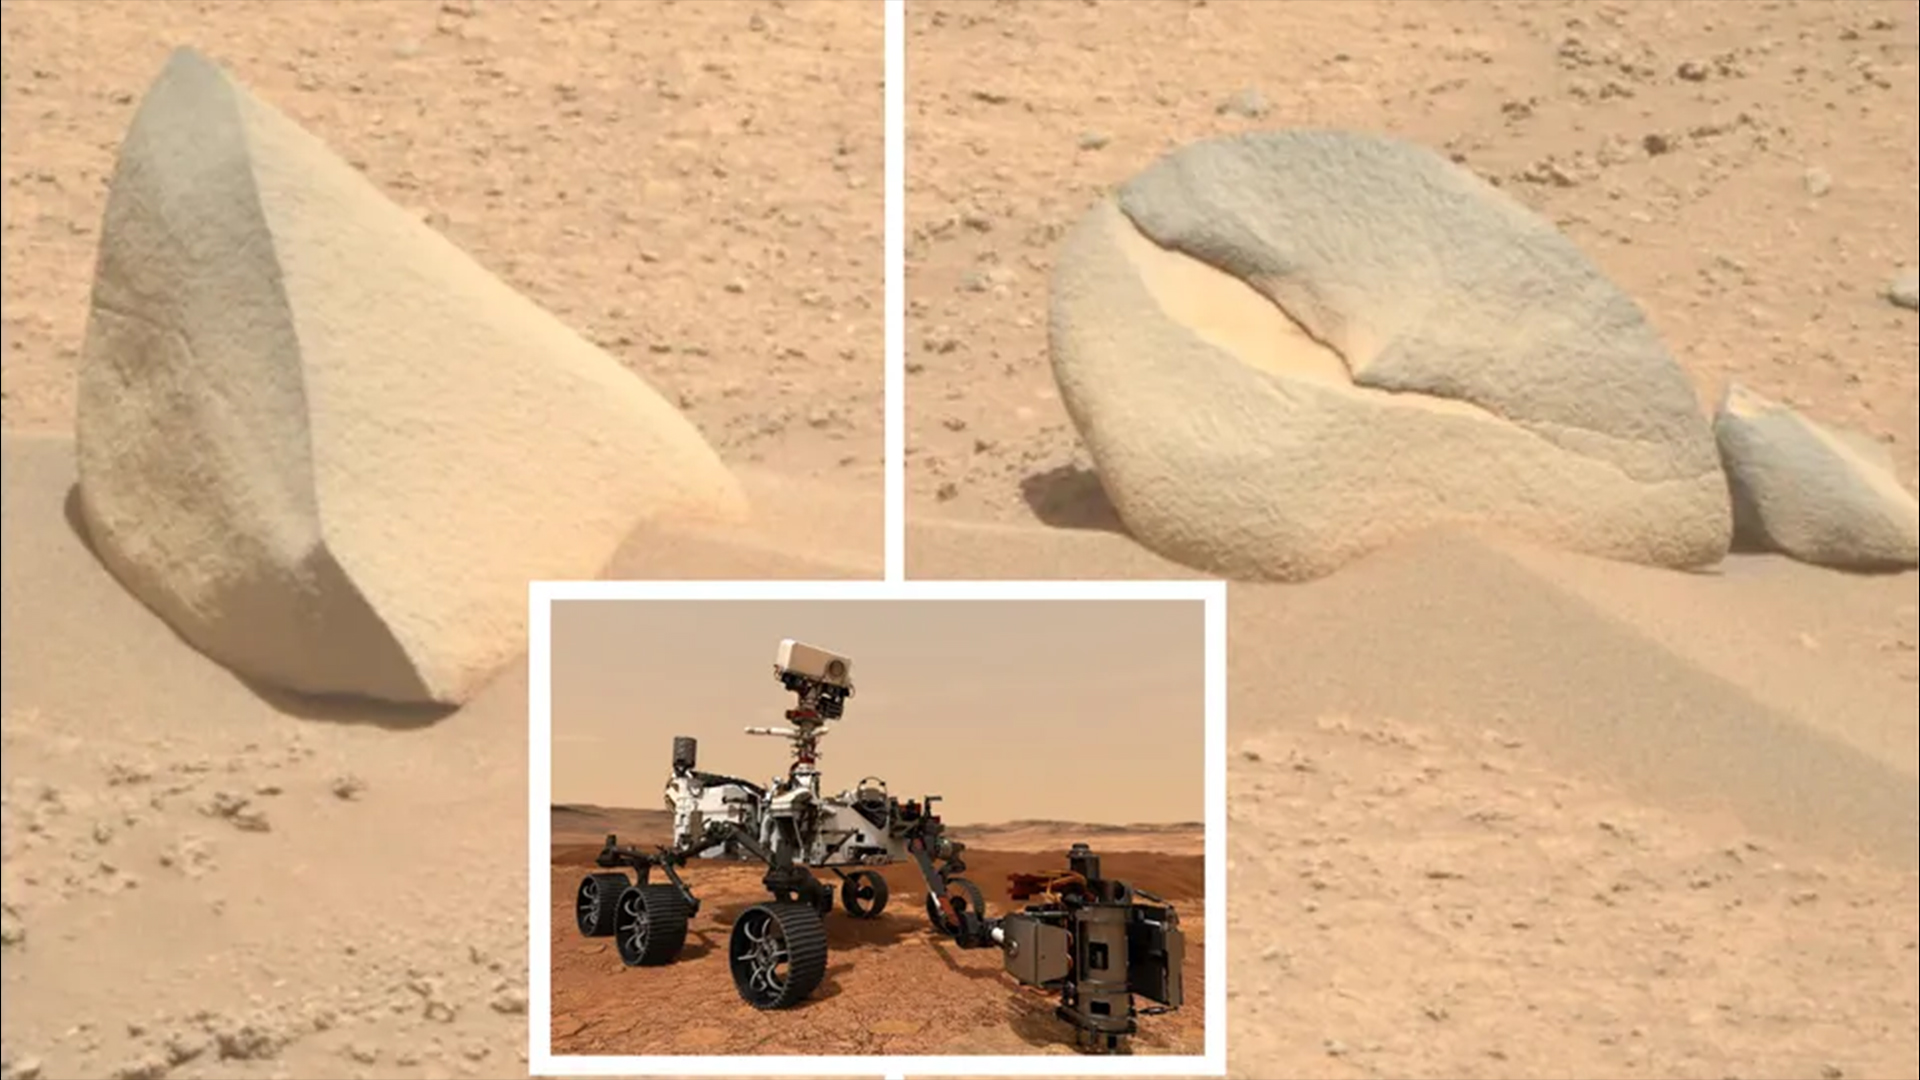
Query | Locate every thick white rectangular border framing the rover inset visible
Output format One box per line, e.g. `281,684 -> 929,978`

526,580 -> 1227,1076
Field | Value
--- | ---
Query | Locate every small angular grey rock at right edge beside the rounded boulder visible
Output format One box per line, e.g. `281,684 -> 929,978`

1713,382 -> 1920,571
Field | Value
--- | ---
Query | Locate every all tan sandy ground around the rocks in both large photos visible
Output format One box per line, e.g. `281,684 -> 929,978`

0,0 -> 1920,1080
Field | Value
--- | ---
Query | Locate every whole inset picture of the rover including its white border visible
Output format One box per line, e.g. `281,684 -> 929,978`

532,582 -> 1225,1076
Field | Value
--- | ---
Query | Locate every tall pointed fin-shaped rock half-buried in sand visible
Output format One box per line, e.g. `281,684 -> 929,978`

75,50 -> 747,703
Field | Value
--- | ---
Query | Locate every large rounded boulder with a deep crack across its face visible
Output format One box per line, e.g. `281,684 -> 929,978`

1050,131 -> 1730,580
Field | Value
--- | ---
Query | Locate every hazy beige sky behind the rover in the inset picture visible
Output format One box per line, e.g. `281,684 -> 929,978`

553,600 -> 1206,824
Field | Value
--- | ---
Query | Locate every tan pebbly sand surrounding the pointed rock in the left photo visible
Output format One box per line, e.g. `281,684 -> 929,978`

0,0 -> 883,1080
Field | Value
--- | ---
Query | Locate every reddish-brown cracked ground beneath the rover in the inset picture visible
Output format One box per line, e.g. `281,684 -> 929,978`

551,807 -> 1206,1057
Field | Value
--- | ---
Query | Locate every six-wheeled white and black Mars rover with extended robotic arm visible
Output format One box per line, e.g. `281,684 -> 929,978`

576,640 -> 1185,1053
